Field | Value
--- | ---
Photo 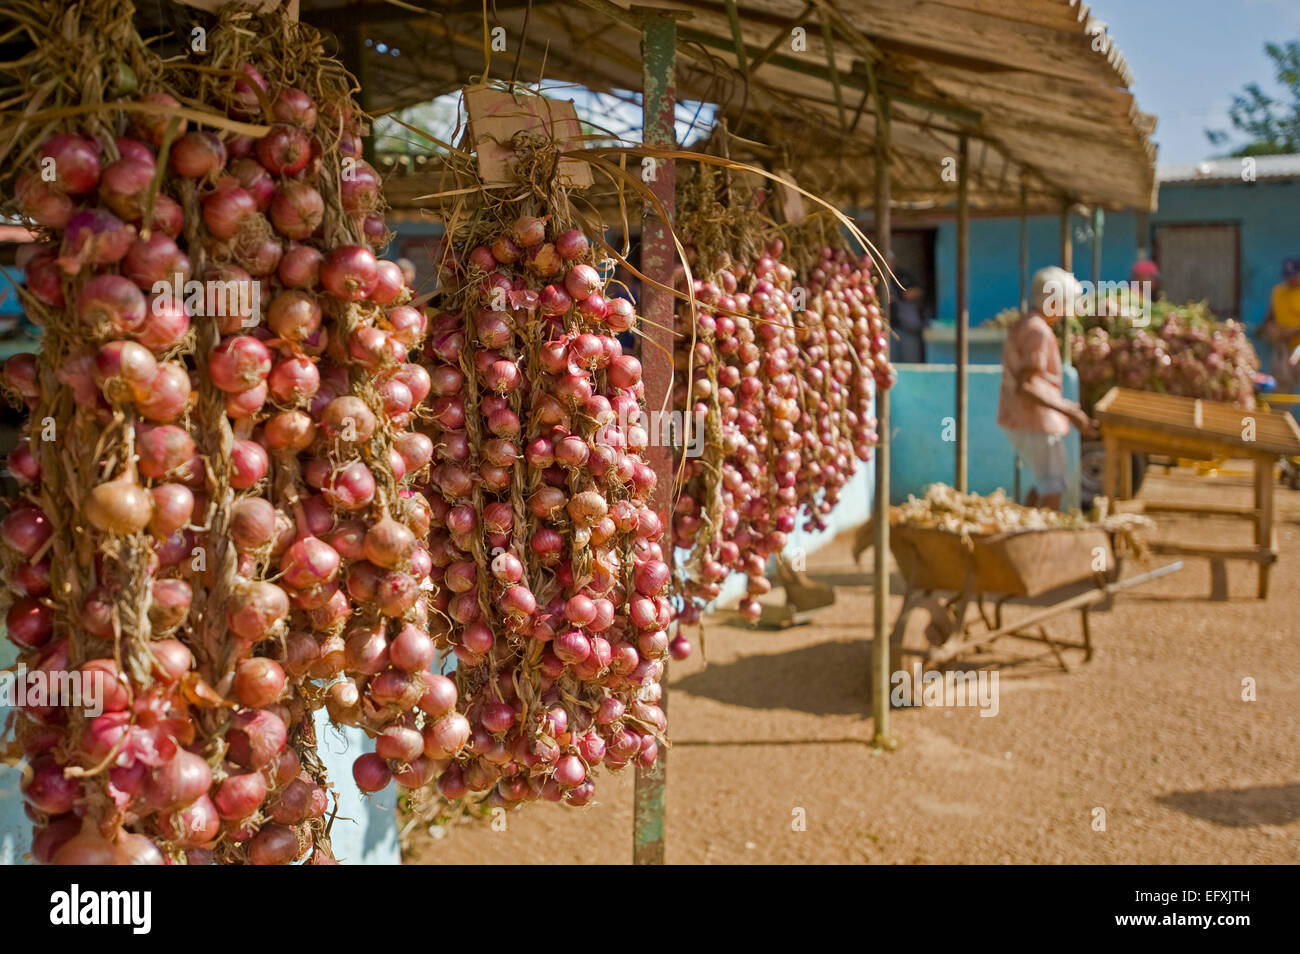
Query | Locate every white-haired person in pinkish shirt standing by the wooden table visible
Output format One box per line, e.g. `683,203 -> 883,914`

997,268 -> 1097,509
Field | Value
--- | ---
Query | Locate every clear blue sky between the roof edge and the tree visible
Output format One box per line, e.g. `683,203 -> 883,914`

1091,0 -> 1300,162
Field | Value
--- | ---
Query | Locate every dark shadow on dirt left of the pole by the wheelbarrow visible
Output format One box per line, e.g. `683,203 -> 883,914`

672,634 -> 871,715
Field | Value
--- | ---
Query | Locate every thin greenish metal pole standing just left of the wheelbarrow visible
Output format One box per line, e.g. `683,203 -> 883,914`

871,97 -> 897,749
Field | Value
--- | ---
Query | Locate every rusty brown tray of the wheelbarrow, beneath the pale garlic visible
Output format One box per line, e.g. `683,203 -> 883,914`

889,524 -> 1115,597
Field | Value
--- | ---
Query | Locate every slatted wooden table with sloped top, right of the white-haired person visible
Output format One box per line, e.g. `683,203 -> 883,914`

1093,387 -> 1300,599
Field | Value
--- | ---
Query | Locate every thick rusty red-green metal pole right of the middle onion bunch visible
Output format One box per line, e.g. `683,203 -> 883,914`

632,10 -> 677,864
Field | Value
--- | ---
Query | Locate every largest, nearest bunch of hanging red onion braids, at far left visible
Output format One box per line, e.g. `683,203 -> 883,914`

0,1 -> 426,864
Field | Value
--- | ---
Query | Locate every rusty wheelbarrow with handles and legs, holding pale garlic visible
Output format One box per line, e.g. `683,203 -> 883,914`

889,524 -> 1183,672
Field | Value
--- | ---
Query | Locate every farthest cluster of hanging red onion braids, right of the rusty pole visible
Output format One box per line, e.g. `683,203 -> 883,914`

673,175 -> 892,631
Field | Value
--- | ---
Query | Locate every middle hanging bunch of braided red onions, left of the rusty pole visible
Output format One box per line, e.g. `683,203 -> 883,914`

399,132 -> 672,821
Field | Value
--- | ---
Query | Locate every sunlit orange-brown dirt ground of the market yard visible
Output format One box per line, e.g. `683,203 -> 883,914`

407,465 -> 1300,864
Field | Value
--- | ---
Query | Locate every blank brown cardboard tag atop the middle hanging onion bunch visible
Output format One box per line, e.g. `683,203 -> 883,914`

464,86 -> 592,188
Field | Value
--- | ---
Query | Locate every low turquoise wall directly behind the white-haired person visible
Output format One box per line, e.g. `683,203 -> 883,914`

889,364 -> 1079,507
